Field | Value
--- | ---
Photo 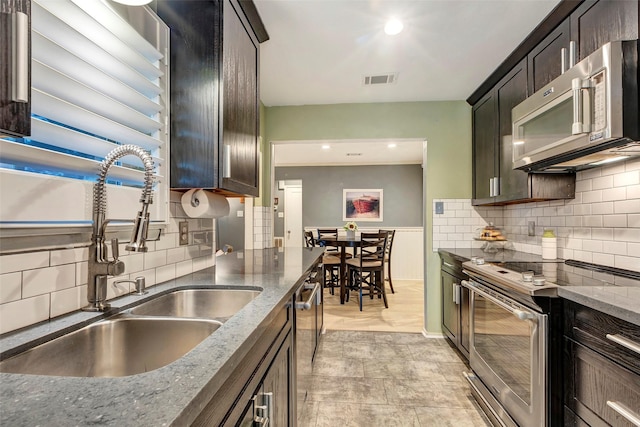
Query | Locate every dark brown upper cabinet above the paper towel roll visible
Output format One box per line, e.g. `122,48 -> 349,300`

157,0 -> 268,196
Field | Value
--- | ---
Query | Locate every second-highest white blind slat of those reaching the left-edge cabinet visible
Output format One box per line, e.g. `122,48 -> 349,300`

31,31 -> 163,116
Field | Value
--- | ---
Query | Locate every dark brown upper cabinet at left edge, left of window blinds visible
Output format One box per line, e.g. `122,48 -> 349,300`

0,0 -> 31,136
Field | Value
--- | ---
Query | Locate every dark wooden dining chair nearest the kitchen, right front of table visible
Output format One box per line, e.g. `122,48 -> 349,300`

346,232 -> 389,311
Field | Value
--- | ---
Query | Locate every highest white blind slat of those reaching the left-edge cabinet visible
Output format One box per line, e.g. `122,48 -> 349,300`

31,3 -> 162,97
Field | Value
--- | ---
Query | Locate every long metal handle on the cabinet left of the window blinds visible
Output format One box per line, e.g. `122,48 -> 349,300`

11,12 -> 29,102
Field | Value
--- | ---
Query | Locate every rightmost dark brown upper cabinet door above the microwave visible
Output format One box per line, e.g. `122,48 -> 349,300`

571,0 -> 640,62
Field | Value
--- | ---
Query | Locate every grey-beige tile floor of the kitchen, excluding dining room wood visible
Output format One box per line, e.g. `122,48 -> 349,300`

300,330 -> 490,427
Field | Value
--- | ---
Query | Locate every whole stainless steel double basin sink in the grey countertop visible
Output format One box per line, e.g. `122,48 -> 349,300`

0,289 -> 260,377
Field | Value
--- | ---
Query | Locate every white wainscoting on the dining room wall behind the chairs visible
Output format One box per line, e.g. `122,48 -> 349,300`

305,226 -> 424,281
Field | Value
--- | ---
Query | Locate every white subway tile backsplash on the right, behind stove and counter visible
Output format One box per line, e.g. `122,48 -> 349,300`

432,159 -> 640,271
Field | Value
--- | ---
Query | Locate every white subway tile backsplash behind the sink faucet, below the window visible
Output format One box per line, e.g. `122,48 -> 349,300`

0,192 -> 215,333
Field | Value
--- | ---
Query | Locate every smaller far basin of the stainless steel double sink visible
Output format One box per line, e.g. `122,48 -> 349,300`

131,289 -> 260,321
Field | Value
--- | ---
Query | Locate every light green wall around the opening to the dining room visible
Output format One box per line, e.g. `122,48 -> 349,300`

257,101 -> 471,332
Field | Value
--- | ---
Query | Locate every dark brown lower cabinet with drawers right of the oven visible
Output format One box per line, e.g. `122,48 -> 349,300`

564,303 -> 640,427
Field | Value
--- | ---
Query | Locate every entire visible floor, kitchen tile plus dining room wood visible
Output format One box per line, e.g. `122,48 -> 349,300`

300,280 -> 490,427
